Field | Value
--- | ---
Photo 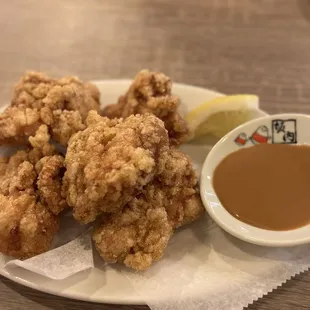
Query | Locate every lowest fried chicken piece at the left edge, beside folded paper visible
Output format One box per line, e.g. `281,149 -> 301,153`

0,194 -> 58,259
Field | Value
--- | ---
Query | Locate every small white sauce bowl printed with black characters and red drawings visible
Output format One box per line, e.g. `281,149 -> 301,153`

200,114 -> 310,247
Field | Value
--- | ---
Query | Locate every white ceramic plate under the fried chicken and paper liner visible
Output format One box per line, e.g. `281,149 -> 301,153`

0,80 -> 265,304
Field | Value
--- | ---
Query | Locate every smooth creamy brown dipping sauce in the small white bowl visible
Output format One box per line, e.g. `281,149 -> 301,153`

213,144 -> 310,230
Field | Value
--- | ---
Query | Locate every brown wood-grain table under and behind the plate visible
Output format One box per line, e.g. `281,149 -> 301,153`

0,0 -> 310,310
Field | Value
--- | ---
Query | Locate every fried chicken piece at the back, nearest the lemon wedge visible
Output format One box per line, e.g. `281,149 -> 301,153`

102,70 -> 189,145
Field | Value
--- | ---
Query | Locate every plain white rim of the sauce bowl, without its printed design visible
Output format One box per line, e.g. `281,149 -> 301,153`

200,113 -> 310,247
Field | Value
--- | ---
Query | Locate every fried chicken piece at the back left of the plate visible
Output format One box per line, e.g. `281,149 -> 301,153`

0,72 -> 99,145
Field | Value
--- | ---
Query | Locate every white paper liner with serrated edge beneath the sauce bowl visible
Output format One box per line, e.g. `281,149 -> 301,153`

123,219 -> 310,310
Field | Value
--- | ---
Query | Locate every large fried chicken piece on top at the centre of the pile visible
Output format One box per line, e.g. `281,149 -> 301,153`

63,111 -> 169,223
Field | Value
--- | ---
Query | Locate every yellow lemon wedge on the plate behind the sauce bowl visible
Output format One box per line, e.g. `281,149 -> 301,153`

185,95 -> 259,140
